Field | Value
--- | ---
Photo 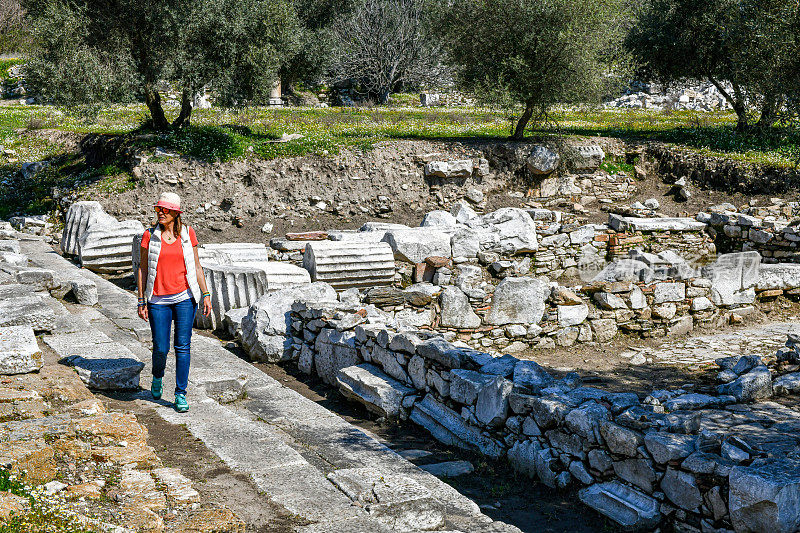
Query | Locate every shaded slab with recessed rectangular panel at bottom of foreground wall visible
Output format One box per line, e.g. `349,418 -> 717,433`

578,481 -> 661,531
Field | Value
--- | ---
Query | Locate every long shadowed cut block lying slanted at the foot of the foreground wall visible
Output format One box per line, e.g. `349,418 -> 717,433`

411,394 -> 504,459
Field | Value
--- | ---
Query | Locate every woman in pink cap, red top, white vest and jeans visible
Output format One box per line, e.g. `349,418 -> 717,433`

136,192 -> 211,413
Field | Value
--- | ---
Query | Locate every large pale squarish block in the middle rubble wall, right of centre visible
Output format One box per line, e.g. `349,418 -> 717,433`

486,277 -> 549,326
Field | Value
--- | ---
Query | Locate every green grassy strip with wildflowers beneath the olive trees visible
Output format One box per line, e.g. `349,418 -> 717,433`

0,101 -> 800,167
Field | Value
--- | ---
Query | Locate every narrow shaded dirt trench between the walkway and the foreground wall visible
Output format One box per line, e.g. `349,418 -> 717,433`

247,353 -> 617,533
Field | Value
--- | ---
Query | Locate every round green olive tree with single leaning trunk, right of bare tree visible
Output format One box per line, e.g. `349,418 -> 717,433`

440,0 -> 627,139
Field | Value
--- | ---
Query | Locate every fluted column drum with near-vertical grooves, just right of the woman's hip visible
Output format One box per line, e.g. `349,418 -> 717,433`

195,264 -> 267,330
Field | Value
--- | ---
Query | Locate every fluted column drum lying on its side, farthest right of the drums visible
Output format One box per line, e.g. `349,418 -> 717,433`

303,241 -> 396,290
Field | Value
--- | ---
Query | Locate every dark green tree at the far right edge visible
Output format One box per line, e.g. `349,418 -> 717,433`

626,0 -> 800,130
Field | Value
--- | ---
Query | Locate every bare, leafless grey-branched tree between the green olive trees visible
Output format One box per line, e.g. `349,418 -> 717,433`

330,0 -> 445,103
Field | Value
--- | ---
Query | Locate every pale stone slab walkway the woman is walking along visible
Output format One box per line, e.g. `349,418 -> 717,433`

22,241 -> 519,533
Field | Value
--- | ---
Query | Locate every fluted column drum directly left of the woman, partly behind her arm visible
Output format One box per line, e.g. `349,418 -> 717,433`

78,217 -> 144,273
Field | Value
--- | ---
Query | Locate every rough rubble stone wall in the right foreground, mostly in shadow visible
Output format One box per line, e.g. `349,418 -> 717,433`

280,302 -> 800,533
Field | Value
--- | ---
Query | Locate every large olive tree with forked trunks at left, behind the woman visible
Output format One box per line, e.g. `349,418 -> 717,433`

23,0 -> 297,130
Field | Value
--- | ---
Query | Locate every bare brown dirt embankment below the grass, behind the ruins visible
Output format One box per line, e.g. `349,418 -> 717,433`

51,136 -> 800,242
